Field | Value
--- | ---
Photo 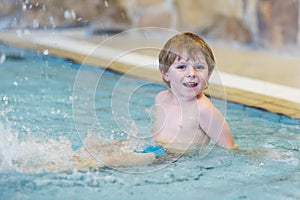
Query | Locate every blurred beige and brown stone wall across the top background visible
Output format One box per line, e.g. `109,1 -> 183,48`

0,0 -> 300,49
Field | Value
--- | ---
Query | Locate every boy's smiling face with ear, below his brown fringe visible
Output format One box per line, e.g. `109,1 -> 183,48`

161,50 -> 210,98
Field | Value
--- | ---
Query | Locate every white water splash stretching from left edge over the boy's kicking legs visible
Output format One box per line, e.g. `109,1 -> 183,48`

0,115 -> 151,172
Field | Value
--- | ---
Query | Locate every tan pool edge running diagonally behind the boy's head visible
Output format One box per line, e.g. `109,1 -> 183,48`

0,28 -> 300,118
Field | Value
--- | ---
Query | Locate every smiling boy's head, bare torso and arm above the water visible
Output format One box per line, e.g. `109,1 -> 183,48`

153,32 -> 237,152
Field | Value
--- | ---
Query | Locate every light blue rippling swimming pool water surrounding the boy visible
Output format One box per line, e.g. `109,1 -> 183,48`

0,46 -> 300,199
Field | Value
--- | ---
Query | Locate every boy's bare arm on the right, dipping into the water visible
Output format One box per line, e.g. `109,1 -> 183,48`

200,102 -> 238,149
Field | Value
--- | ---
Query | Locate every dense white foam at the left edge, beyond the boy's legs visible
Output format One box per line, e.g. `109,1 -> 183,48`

0,119 -> 81,171
